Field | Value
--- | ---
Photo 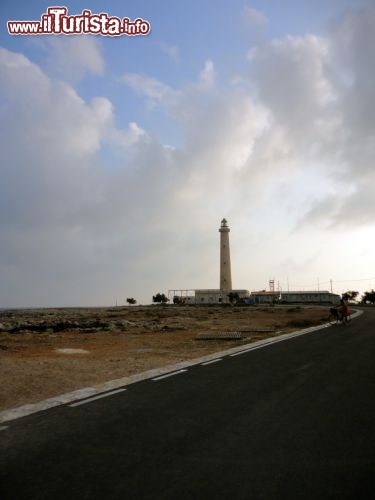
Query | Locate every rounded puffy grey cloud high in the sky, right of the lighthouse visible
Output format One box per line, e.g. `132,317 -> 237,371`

250,35 -> 335,142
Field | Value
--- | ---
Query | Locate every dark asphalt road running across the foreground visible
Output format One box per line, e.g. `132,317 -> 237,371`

0,309 -> 375,500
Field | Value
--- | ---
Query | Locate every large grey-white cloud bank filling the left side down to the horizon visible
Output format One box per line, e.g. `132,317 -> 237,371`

0,49 -> 150,305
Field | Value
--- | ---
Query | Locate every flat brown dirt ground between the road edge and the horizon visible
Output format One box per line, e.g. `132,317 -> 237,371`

0,305 -> 329,410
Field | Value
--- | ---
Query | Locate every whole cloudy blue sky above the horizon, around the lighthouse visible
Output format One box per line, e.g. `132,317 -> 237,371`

0,0 -> 375,308
